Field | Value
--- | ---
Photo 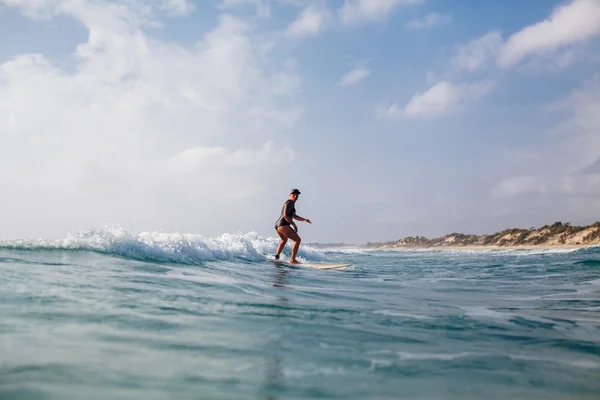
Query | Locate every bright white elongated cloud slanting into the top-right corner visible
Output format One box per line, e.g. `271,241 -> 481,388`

498,0 -> 600,67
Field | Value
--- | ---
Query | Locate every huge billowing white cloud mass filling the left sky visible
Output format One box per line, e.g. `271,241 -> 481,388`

0,0 -> 301,235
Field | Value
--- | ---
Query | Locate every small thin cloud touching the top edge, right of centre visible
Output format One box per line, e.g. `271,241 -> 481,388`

338,0 -> 425,25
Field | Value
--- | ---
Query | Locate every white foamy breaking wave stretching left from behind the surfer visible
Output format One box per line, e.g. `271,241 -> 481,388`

0,227 -> 327,264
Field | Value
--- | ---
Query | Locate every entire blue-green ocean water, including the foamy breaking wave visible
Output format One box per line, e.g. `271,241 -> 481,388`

0,228 -> 600,400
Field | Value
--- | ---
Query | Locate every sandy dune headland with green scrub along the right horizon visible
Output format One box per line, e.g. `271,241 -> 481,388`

366,222 -> 600,249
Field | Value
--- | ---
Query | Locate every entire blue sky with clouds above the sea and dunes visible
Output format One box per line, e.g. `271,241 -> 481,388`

0,0 -> 600,244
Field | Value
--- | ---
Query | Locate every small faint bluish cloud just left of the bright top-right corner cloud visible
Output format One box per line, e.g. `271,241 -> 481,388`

452,31 -> 502,71
